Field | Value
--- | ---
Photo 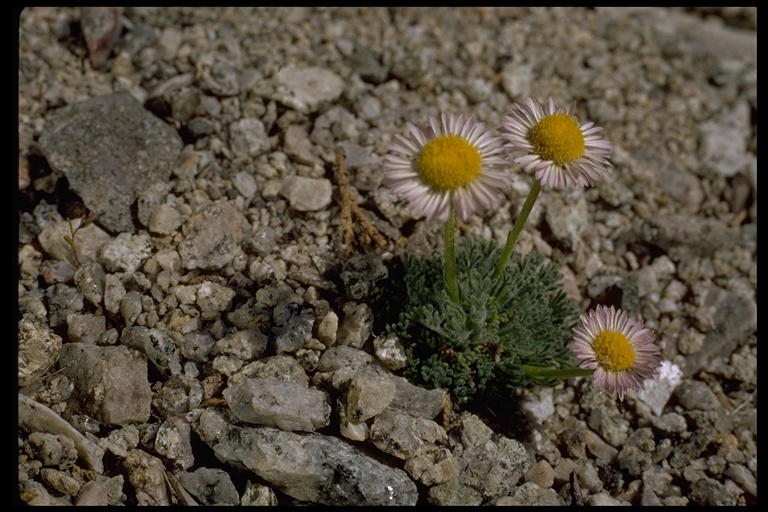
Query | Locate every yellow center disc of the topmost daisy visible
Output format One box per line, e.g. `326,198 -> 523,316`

529,112 -> 584,166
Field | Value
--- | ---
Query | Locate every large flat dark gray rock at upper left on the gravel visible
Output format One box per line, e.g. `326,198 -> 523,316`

39,91 -> 182,232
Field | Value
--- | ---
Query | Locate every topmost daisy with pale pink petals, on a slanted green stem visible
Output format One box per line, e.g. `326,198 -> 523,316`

501,97 -> 612,188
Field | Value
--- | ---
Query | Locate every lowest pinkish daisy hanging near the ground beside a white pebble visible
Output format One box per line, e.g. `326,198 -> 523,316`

573,306 -> 661,400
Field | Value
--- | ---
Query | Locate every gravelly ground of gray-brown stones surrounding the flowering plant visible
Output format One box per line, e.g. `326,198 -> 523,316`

16,7 -> 757,506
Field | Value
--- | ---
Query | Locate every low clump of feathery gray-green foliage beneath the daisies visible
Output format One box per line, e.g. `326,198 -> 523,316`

381,237 -> 578,404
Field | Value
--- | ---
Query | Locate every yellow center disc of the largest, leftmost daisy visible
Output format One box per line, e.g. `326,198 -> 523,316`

418,135 -> 482,191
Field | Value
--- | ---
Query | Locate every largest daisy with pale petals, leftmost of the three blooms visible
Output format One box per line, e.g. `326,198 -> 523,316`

384,113 -> 512,222
